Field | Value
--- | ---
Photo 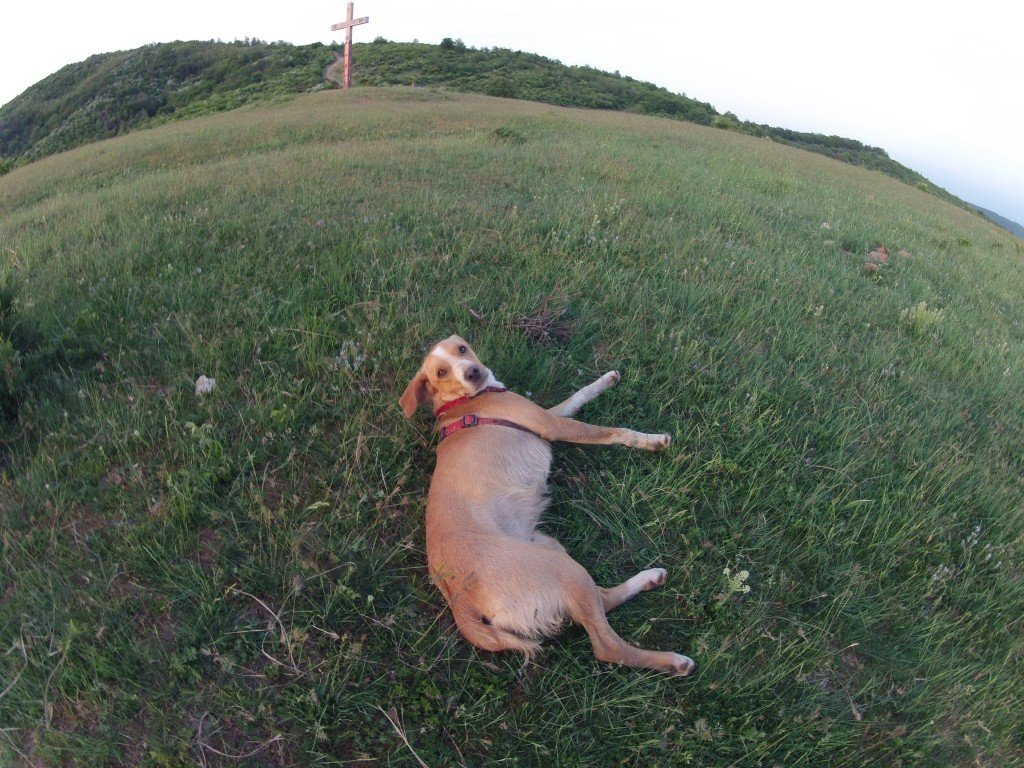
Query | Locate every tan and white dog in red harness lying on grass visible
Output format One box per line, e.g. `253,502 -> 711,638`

399,336 -> 694,676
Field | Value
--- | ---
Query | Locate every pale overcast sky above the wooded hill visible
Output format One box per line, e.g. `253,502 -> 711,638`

0,0 -> 1024,223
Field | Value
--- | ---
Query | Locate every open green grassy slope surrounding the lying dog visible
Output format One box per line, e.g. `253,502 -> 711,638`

0,88 -> 1024,766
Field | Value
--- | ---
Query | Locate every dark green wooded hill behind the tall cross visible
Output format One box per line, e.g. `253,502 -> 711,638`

0,38 -> 973,210
